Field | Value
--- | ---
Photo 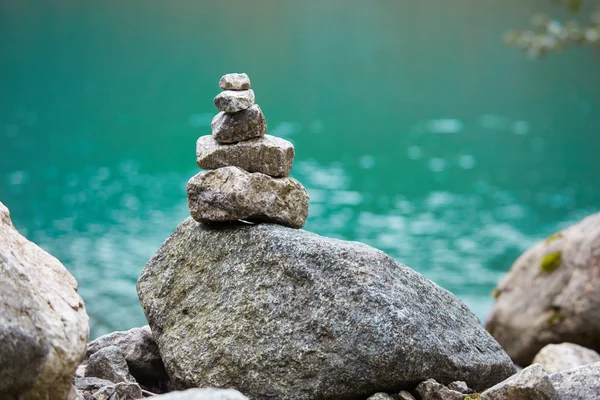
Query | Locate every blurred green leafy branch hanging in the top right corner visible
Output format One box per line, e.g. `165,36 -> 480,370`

504,0 -> 600,58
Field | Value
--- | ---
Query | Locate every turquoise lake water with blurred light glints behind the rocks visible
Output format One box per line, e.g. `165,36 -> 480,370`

0,0 -> 600,336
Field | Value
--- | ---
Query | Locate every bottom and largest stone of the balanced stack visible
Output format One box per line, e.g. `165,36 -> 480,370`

187,167 -> 308,228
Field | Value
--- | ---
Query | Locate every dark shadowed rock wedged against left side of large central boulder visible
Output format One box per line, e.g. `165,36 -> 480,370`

87,325 -> 171,393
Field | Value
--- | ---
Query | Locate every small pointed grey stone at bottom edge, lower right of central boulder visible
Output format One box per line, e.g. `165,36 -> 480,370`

481,364 -> 561,400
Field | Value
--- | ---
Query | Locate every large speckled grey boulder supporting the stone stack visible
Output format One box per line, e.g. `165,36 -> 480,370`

137,218 -> 514,400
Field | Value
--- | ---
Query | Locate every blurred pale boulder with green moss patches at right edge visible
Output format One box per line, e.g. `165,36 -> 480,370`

486,213 -> 600,365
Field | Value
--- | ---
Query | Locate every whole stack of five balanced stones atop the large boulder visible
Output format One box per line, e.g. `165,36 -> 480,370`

187,74 -> 308,228
